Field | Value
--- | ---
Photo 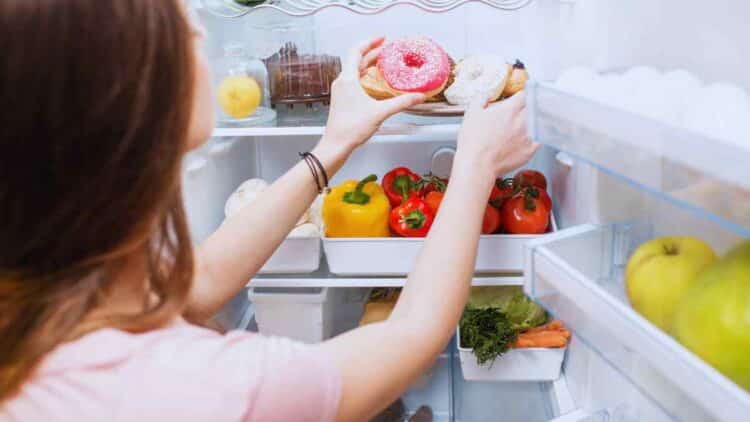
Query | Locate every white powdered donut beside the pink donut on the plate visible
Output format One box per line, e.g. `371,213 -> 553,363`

445,55 -> 512,105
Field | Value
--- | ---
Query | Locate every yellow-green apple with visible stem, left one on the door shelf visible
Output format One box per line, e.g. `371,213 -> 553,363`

625,236 -> 716,331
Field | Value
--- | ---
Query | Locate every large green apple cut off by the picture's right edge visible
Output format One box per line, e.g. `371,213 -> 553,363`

673,242 -> 750,391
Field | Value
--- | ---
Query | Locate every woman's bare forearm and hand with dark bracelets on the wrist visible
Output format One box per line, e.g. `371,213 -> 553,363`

186,38 -> 424,320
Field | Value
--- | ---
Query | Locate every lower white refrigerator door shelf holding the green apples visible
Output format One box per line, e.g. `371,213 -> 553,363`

524,224 -> 750,421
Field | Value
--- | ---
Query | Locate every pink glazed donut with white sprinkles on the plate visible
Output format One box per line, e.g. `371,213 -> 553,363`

378,37 -> 451,98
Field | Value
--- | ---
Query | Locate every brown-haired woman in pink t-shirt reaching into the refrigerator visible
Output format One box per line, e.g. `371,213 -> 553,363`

0,0 -> 536,421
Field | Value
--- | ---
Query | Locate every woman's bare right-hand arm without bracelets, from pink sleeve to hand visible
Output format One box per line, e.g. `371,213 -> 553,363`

320,93 -> 537,421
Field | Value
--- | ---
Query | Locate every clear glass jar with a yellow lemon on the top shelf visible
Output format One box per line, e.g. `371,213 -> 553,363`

215,43 -> 276,126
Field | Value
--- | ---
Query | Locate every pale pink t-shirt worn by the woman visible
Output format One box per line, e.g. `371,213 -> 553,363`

0,323 -> 341,422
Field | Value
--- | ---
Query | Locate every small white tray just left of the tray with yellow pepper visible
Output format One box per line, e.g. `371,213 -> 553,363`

260,237 -> 320,274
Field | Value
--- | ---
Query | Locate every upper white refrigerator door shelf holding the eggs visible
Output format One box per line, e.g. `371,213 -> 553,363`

528,82 -> 750,237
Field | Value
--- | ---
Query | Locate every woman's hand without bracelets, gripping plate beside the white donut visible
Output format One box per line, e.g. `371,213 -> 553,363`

454,91 -> 539,180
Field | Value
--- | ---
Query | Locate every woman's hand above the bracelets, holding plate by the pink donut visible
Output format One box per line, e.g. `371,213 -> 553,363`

320,37 -> 425,152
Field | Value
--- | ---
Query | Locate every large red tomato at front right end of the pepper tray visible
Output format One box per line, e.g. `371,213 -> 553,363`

502,193 -> 550,234
